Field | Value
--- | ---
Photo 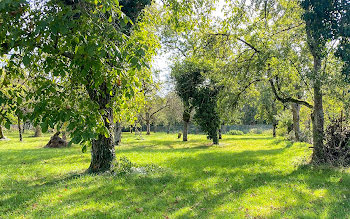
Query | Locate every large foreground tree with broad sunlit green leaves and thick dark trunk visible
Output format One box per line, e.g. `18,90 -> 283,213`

0,0 -> 156,173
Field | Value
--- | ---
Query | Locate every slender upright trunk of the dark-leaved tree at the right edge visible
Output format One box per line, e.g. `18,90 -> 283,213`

312,56 -> 325,163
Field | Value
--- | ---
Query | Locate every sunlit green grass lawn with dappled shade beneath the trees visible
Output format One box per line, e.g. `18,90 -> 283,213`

0,133 -> 350,218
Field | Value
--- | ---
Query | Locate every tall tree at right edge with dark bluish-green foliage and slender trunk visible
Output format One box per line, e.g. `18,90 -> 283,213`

301,0 -> 350,163
